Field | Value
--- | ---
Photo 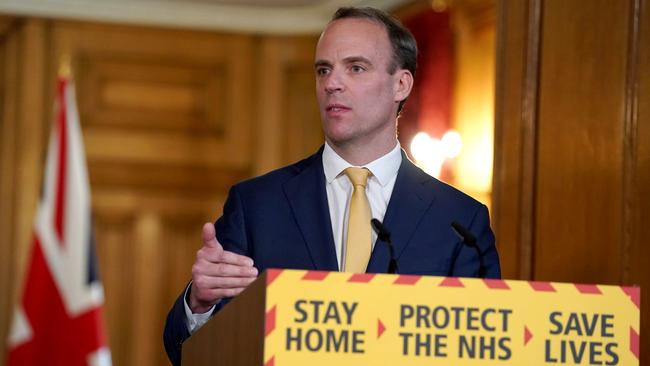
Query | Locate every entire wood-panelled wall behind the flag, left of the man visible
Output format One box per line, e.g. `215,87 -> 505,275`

0,17 -> 322,366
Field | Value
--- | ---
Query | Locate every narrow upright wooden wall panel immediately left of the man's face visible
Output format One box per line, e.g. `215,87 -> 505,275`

255,37 -> 324,174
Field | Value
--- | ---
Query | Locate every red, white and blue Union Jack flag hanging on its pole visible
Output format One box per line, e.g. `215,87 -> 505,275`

7,76 -> 111,366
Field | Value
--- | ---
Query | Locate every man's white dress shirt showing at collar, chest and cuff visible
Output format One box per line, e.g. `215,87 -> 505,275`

183,142 -> 402,334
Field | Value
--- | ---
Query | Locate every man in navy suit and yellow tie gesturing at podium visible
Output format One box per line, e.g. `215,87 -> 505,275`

164,8 -> 500,364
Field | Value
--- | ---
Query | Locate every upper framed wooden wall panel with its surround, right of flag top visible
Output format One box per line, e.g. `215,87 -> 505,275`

53,22 -> 253,168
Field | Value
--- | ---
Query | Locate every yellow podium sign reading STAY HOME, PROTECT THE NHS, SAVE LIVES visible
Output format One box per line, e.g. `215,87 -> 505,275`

264,270 -> 640,366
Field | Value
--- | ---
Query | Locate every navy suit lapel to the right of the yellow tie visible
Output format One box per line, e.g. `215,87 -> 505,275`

367,151 -> 435,273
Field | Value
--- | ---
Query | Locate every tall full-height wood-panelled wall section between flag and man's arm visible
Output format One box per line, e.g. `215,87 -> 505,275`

45,22 -> 254,365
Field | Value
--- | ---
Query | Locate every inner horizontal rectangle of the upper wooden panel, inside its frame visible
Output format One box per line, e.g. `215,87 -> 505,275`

78,59 -> 228,135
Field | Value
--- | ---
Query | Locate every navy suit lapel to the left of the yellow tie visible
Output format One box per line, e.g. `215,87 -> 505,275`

283,148 -> 338,271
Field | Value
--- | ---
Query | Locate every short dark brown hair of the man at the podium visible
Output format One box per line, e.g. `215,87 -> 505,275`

330,7 -> 418,116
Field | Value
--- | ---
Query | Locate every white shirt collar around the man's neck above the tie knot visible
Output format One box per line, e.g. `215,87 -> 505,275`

323,141 -> 402,187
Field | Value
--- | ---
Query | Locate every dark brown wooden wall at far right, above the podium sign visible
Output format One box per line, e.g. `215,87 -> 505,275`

493,0 -> 650,364
